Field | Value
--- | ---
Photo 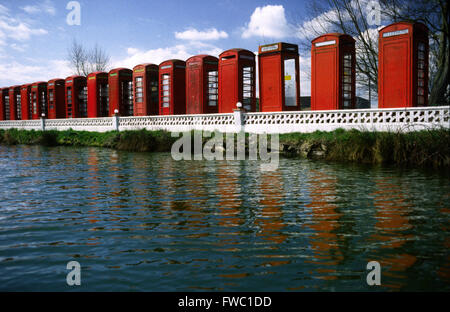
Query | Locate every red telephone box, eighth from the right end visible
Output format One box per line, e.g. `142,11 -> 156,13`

108,68 -> 133,116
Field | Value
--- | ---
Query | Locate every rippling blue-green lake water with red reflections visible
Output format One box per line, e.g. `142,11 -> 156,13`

0,146 -> 450,291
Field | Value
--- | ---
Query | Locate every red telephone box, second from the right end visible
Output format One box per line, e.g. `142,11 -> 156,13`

311,33 -> 356,110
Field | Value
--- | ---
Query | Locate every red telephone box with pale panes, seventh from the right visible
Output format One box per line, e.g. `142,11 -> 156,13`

133,64 -> 159,116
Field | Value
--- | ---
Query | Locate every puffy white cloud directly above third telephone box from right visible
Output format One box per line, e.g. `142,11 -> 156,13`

242,5 -> 294,39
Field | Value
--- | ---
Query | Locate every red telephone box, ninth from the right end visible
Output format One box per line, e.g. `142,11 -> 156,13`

87,72 -> 109,118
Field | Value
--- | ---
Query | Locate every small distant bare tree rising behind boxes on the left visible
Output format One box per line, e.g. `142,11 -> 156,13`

68,39 -> 110,76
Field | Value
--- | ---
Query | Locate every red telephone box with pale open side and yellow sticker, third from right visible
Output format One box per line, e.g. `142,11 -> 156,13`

258,42 -> 300,112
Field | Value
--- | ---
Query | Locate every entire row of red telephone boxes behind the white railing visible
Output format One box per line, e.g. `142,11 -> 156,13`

0,22 -> 429,120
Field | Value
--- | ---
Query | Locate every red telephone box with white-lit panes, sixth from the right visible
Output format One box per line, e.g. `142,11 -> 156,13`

159,60 -> 186,115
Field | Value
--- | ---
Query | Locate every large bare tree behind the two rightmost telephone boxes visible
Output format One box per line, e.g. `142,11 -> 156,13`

300,0 -> 450,105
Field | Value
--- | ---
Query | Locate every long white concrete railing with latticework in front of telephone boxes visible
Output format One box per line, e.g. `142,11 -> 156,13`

0,106 -> 450,133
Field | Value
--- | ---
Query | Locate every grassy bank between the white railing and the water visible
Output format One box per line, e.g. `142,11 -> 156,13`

0,129 -> 450,170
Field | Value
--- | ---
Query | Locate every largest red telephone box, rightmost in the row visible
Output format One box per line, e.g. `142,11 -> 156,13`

378,22 -> 429,108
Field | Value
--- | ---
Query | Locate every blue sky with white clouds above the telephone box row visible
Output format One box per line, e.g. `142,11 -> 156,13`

0,0 -> 384,100
